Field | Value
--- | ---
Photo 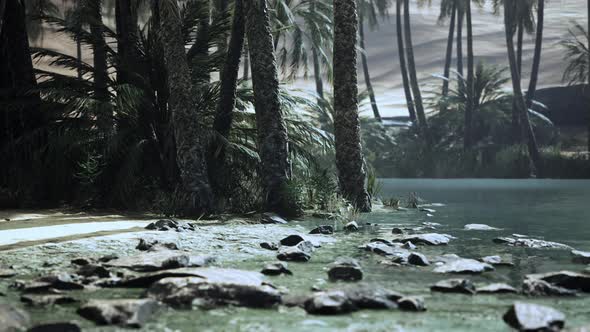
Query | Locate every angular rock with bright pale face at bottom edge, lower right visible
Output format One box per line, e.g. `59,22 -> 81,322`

502,302 -> 565,331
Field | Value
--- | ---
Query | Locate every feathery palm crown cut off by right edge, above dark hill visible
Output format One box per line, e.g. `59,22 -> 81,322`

561,23 -> 590,151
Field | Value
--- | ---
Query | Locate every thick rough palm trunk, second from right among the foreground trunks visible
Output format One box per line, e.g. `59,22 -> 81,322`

244,0 -> 292,214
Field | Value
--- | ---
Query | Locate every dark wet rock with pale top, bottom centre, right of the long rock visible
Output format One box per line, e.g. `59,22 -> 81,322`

304,291 -> 357,315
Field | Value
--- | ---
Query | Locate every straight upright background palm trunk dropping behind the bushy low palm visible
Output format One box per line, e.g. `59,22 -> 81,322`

463,0 -> 475,150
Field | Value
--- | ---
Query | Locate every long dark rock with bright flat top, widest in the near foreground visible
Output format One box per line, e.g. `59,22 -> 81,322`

147,268 -> 281,308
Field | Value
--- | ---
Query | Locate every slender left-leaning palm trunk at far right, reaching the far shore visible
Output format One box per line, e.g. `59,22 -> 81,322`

504,0 -> 543,175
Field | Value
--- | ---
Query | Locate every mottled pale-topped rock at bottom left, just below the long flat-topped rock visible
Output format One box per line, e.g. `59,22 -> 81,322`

77,299 -> 159,328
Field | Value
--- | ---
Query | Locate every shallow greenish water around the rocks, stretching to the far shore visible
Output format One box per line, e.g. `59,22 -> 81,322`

0,180 -> 590,331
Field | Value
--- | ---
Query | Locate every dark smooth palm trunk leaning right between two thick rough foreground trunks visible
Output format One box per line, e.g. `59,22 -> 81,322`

213,0 -> 245,137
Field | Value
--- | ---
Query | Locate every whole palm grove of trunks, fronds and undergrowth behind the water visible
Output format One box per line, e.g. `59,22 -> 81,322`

0,0 -> 590,217
